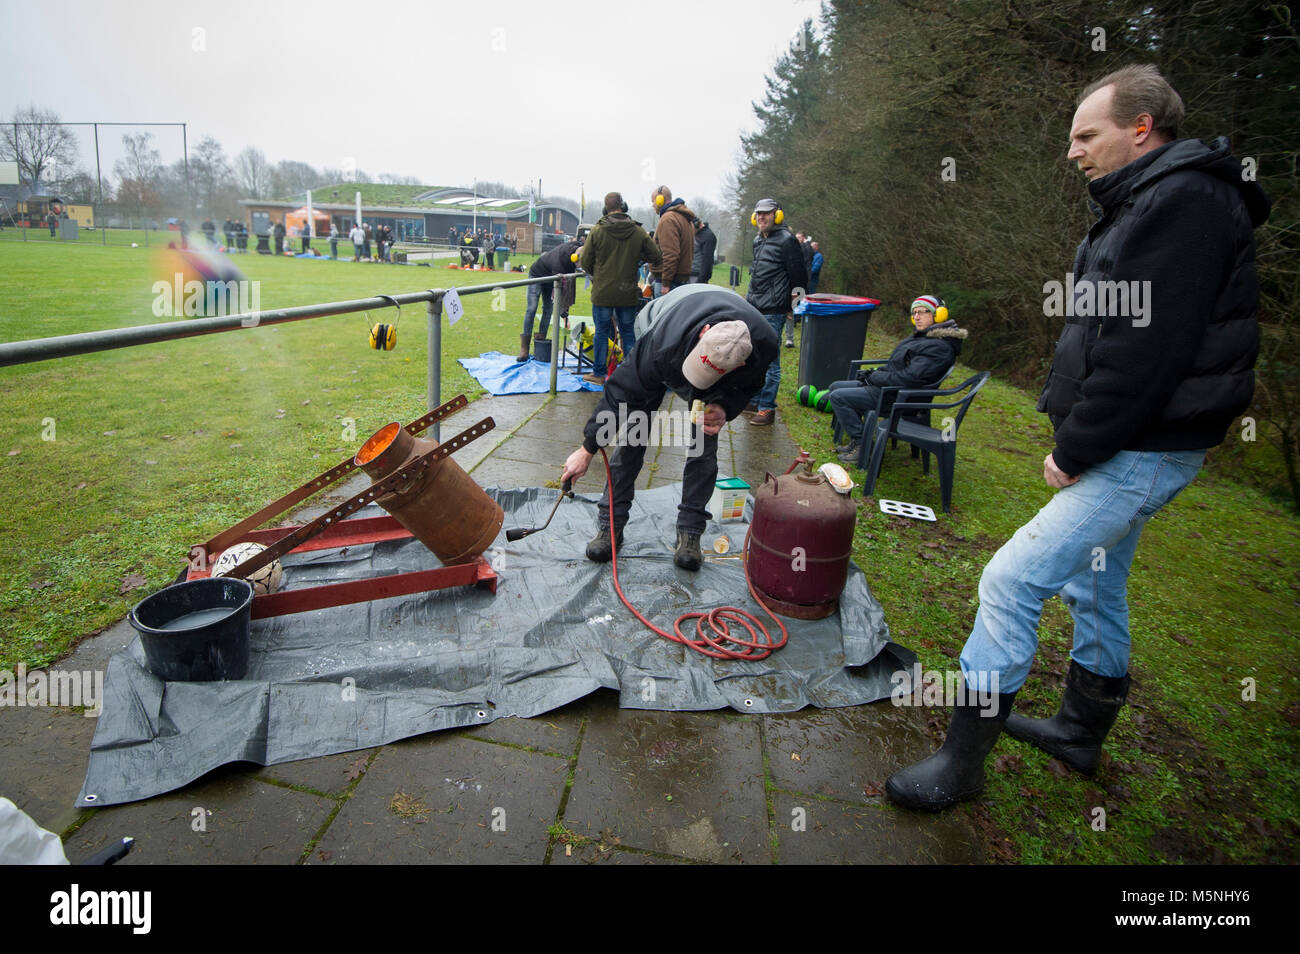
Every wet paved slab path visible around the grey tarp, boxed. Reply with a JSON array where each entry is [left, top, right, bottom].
[[0, 393, 984, 864]]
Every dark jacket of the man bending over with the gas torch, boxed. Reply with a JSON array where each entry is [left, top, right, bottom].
[[582, 285, 780, 454]]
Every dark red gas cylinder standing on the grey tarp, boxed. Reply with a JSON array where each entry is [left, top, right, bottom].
[[749, 461, 858, 620]]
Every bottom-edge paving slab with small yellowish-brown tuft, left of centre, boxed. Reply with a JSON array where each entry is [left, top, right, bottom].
[[308, 733, 568, 864]]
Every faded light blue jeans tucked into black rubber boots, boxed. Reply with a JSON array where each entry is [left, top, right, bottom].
[[961, 451, 1205, 693]]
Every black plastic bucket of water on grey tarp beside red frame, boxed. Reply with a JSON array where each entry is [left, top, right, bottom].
[[129, 576, 252, 682]]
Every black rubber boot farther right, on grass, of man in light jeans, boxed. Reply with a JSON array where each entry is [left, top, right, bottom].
[[1006, 659, 1128, 775]]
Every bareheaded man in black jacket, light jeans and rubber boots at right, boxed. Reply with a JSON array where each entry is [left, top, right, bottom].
[[885, 66, 1269, 811]]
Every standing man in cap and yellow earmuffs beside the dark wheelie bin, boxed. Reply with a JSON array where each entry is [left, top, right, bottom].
[[746, 199, 809, 428]]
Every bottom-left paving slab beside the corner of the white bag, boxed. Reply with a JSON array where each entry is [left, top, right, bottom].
[[65, 766, 335, 864]]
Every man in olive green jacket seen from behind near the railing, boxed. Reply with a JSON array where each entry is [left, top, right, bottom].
[[579, 192, 663, 387]]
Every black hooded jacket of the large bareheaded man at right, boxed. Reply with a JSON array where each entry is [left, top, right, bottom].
[[1039, 139, 1270, 477]]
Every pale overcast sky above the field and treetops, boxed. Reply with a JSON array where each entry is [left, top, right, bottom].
[[0, 0, 818, 205]]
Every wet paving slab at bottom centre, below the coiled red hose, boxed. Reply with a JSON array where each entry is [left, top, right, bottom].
[[564, 706, 768, 863]]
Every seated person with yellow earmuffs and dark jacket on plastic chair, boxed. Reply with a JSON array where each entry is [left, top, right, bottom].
[[827, 295, 969, 464]]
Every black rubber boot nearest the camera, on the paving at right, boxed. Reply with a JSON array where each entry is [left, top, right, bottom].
[[885, 682, 1015, 811]]
